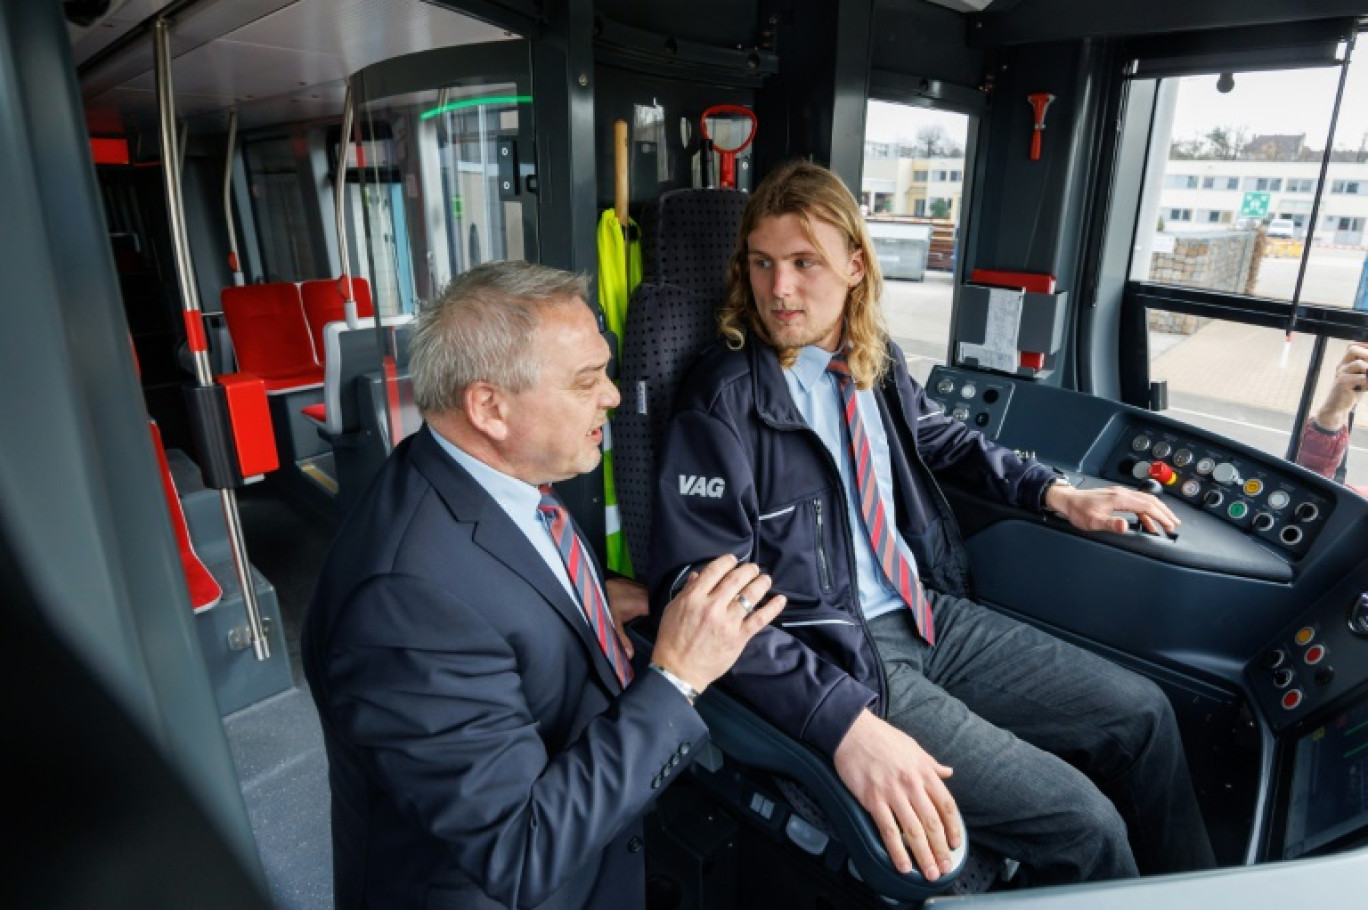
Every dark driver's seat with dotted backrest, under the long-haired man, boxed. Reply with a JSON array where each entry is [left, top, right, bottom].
[[613, 189, 999, 902]]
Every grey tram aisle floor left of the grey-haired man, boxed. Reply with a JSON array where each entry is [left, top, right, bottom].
[[223, 483, 335, 910]]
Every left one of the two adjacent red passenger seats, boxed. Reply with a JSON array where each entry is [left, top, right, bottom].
[[220, 282, 323, 385]]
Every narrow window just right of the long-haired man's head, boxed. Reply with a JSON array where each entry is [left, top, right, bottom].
[[860, 101, 970, 382]]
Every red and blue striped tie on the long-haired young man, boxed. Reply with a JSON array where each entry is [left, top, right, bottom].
[[826, 353, 936, 645]]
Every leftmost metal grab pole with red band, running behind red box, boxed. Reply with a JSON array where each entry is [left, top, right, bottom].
[[153, 19, 271, 661]]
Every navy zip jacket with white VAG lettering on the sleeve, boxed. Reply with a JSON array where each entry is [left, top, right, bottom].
[[650, 338, 1055, 757]]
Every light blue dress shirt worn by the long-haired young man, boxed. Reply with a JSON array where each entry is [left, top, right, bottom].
[[784, 345, 917, 620]]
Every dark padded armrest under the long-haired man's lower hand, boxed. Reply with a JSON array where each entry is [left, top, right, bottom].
[[628, 621, 969, 900]]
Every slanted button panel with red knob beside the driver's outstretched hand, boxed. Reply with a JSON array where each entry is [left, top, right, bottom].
[[1101, 420, 1334, 556]]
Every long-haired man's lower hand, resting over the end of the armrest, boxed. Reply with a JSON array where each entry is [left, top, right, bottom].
[[836, 710, 964, 881]]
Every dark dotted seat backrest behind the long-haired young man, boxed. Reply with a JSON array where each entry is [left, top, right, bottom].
[[613, 189, 747, 577]]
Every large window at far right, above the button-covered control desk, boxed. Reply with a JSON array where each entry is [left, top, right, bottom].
[[1127, 60, 1368, 484]]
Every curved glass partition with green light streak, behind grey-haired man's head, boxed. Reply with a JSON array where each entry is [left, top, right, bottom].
[[347, 40, 538, 446]]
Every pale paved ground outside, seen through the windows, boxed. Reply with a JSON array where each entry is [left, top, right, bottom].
[[884, 248, 1368, 484]]
